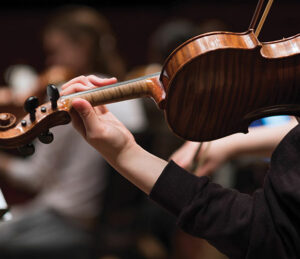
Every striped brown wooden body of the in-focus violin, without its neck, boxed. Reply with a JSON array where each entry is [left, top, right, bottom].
[[160, 30, 300, 141]]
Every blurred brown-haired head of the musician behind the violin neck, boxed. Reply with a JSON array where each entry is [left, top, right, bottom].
[[43, 6, 125, 79]]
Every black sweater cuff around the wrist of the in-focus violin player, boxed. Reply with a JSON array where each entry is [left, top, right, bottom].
[[149, 161, 209, 216]]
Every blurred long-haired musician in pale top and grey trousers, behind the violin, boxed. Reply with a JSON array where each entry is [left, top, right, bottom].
[[0, 6, 144, 258]]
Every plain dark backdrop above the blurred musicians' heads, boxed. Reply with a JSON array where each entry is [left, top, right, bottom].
[[0, 0, 299, 84]]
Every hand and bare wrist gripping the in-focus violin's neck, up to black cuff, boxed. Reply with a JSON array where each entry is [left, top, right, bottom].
[[62, 76, 167, 194]]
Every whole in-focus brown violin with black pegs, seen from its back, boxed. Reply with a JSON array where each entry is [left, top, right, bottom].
[[0, 0, 300, 155]]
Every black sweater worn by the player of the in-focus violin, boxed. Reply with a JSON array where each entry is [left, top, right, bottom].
[[150, 126, 300, 259]]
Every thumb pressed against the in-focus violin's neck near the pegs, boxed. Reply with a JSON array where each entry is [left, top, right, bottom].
[[72, 98, 98, 134]]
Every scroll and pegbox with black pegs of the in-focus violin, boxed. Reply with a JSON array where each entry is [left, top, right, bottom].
[[0, 85, 71, 155]]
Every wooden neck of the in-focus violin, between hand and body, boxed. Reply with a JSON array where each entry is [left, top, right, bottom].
[[62, 73, 165, 108]]
